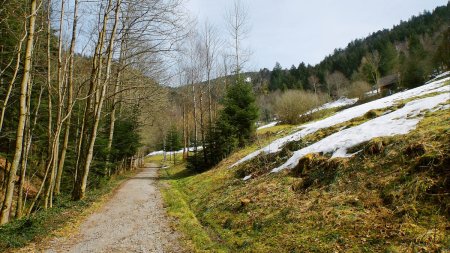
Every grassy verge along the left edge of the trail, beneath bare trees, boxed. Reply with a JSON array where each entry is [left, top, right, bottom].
[[0, 172, 134, 252]]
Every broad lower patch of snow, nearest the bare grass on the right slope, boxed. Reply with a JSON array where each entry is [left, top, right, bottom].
[[272, 93, 450, 172]]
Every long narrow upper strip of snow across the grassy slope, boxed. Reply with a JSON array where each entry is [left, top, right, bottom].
[[231, 77, 450, 167]]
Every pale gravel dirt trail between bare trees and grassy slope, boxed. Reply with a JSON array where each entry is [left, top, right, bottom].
[[45, 164, 183, 252]]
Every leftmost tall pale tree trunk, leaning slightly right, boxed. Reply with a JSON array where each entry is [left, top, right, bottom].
[[0, 0, 37, 224]]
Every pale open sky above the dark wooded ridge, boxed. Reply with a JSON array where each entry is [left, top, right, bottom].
[[186, 0, 447, 70]]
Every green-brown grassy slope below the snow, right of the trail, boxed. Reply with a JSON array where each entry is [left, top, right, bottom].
[[162, 90, 450, 252]]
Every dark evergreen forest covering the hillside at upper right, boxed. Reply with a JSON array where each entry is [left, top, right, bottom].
[[254, 4, 450, 97]]
